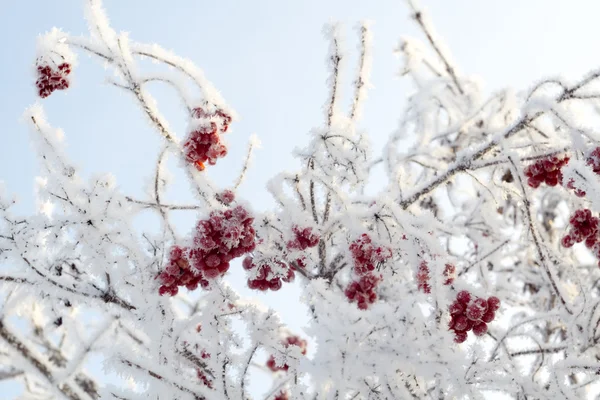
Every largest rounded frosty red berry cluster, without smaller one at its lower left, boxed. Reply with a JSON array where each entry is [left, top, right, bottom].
[[189, 206, 256, 279]]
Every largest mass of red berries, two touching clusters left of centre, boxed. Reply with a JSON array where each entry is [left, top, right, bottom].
[[158, 206, 256, 296]]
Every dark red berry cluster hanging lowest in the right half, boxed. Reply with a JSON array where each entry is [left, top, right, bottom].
[[448, 290, 500, 343]]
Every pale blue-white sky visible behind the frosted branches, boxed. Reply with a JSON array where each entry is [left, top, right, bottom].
[[0, 0, 600, 399]]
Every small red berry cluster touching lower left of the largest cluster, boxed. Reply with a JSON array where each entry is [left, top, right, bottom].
[[158, 246, 208, 296]]
